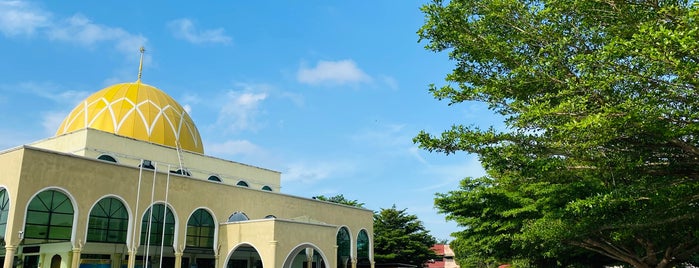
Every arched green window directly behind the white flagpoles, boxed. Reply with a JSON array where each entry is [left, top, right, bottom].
[[141, 204, 175, 246]]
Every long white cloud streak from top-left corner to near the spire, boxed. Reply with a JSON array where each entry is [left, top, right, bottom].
[[0, 1, 147, 57]]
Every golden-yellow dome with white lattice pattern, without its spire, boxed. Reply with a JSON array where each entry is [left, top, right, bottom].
[[56, 79, 204, 154]]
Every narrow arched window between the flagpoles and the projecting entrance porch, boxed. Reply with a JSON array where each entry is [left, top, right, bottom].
[[187, 208, 216, 248]]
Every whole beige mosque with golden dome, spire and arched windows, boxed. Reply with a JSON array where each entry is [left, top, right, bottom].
[[0, 50, 374, 268]]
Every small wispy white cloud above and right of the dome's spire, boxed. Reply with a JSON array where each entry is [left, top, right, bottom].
[[168, 19, 232, 44]]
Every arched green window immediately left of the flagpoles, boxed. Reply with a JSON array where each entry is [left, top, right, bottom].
[[87, 197, 129, 244]]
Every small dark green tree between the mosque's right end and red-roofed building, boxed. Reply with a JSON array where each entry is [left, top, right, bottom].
[[374, 205, 437, 267]]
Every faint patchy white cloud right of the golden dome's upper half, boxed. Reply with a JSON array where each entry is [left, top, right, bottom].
[[216, 91, 268, 131]]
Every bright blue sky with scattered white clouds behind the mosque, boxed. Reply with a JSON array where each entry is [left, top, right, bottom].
[[0, 0, 500, 240]]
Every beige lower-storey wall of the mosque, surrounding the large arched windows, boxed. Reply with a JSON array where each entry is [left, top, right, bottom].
[[0, 147, 373, 267]]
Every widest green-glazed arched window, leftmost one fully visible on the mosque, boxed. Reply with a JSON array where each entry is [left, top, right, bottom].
[[24, 190, 73, 243]]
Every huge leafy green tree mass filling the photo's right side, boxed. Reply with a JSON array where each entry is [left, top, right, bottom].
[[415, 0, 699, 267]]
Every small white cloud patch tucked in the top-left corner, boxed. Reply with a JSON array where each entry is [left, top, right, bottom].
[[0, 1, 51, 36]]
